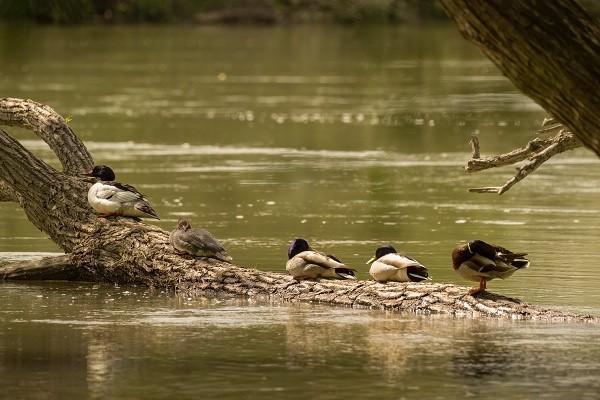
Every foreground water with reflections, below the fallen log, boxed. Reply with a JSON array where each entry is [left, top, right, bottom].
[[0, 283, 600, 399]]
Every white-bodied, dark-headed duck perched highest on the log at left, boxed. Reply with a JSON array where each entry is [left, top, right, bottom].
[[84, 165, 160, 219]]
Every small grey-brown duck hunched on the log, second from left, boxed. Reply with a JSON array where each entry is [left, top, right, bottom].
[[169, 218, 233, 262]]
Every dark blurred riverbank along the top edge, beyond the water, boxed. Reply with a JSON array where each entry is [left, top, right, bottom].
[[0, 0, 445, 24]]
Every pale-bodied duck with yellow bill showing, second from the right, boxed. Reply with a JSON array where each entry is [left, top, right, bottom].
[[367, 244, 429, 282]]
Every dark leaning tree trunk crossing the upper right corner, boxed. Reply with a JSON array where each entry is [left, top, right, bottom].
[[440, 0, 600, 156]]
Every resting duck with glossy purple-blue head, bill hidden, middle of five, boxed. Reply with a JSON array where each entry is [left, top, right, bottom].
[[285, 239, 356, 280]]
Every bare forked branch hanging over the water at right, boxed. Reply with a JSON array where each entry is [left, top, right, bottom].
[[465, 118, 581, 195]]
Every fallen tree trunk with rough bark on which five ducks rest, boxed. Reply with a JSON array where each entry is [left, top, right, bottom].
[[0, 99, 597, 321]]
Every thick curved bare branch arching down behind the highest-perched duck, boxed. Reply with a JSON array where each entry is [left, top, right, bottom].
[[0, 97, 94, 175]]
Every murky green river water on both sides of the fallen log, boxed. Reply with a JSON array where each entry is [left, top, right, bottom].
[[0, 25, 600, 398]]
